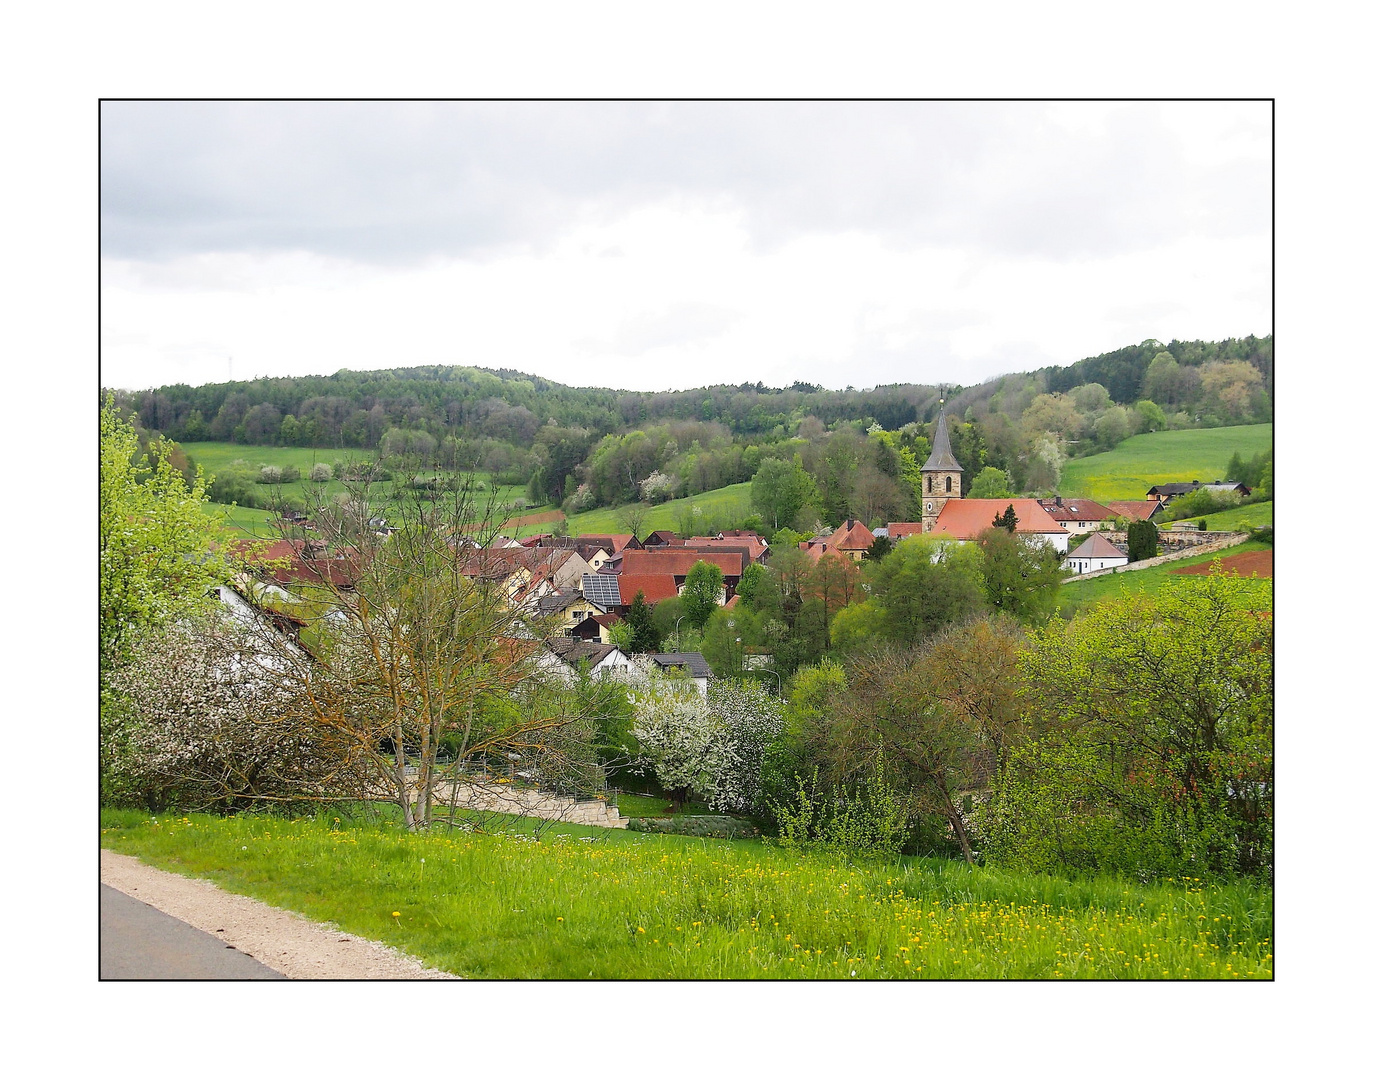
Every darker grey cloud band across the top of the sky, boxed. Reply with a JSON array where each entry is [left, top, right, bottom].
[[102, 102, 1270, 262]]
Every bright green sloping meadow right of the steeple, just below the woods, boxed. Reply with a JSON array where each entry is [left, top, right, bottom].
[[1059, 424, 1273, 502]]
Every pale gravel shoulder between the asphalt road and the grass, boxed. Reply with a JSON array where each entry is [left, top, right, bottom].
[[100, 848, 457, 980]]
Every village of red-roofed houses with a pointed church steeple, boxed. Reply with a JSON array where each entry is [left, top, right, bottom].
[[221, 400, 1249, 708]]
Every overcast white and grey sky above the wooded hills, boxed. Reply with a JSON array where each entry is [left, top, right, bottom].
[[100, 102, 1273, 390]]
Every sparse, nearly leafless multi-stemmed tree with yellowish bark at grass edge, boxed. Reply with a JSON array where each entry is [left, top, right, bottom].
[[247, 463, 606, 829]]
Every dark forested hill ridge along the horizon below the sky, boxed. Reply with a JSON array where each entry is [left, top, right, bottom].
[[119, 335, 1273, 449]]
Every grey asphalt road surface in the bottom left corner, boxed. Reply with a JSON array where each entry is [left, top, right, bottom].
[[100, 884, 286, 978]]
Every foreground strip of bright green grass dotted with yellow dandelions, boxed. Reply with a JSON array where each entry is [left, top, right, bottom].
[[100, 811, 1273, 978]]
